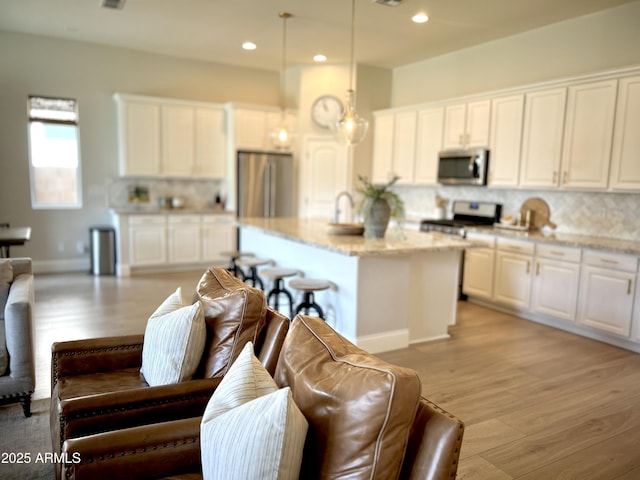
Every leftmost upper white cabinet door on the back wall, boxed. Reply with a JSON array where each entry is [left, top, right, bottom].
[[120, 101, 160, 176]]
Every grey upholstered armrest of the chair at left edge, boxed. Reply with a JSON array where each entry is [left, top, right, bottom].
[[4, 274, 35, 382]]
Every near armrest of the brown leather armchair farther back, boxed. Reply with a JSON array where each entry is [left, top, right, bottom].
[[51, 378, 222, 450]]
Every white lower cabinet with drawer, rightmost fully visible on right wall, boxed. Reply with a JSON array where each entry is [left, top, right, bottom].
[[578, 250, 638, 337]]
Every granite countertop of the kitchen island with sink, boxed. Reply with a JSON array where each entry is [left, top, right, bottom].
[[237, 218, 477, 256]]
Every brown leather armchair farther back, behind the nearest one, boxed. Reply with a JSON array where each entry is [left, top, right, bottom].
[[50, 269, 290, 458]]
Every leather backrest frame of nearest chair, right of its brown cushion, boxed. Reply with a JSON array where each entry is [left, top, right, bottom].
[[401, 398, 464, 480]]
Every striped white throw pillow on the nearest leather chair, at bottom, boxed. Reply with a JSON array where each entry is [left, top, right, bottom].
[[200, 343, 308, 480]]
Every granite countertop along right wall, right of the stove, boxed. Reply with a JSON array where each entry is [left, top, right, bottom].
[[469, 228, 640, 255]]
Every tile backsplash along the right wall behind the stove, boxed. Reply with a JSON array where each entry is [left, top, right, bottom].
[[395, 186, 640, 241]]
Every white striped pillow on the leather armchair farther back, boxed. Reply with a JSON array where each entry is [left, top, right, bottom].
[[141, 287, 207, 386]]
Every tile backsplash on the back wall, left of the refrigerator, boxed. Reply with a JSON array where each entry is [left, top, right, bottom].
[[107, 178, 226, 210]]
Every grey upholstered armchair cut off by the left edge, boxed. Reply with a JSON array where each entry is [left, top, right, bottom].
[[0, 258, 36, 417]]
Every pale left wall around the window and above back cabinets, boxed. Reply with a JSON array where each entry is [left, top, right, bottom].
[[0, 32, 280, 270]]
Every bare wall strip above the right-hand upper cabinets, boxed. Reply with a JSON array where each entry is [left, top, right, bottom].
[[391, 1, 640, 107]]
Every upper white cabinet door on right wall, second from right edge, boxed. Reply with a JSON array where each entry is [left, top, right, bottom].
[[562, 80, 618, 189]]
